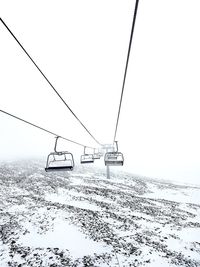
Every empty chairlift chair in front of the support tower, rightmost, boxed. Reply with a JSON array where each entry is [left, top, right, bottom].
[[104, 141, 124, 166]]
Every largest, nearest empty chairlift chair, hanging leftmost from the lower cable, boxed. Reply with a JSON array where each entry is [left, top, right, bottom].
[[45, 136, 74, 172]]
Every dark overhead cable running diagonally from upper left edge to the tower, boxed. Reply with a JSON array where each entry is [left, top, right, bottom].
[[0, 18, 101, 148]]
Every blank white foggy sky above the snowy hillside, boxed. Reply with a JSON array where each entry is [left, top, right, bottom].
[[0, 0, 200, 183]]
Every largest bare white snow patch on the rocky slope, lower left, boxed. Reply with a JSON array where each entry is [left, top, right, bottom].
[[18, 219, 111, 258]]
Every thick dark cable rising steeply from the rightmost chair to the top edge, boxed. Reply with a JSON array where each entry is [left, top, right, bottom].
[[113, 0, 139, 144]]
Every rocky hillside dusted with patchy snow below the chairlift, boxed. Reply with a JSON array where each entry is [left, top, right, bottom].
[[0, 161, 200, 267]]
